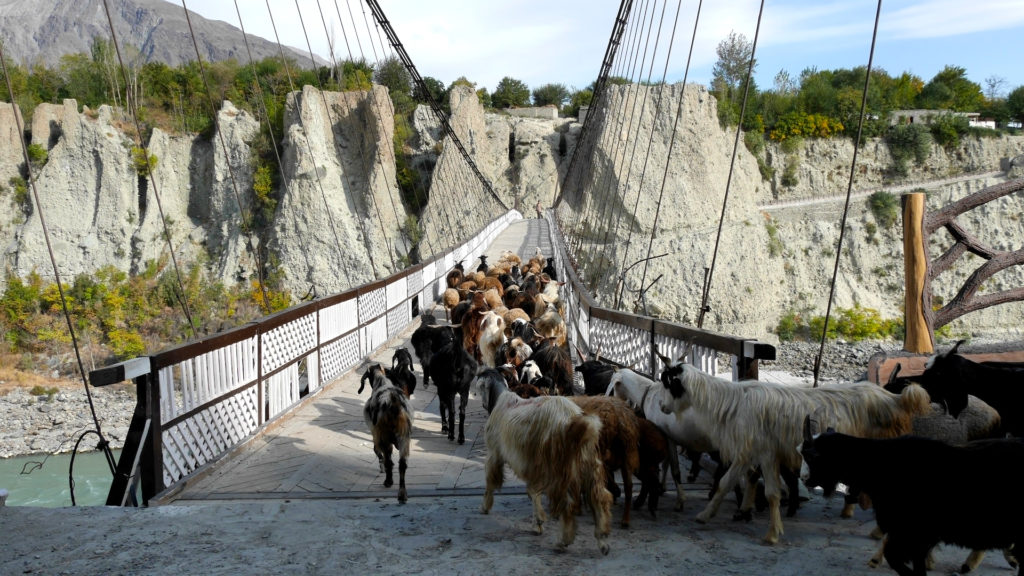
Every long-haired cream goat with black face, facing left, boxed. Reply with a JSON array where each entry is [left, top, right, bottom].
[[660, 357, 931, 544]]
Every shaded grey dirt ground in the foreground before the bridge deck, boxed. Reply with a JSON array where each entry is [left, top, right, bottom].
[[0, 477, 1009, 576]]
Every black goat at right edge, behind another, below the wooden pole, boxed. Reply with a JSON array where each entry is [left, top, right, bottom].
[[909, 340, 1024, 437]]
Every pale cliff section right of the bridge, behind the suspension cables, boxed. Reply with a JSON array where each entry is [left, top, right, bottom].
[[566, 81, 1024, 340]]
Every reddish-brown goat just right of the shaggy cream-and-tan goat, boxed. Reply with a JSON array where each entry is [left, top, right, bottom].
[[572, 396, 638, 528]]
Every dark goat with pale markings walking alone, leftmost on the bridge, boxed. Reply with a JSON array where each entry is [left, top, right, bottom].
[[356, 364, 413, 502]]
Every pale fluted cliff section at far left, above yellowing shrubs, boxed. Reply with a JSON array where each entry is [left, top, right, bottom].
[[0, 100, 259, 291]]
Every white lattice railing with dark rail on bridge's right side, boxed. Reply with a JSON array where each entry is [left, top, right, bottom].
[[545, 211, 775, 380]]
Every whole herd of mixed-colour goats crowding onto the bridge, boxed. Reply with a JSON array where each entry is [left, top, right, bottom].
[[359, 250, 1024, 575]]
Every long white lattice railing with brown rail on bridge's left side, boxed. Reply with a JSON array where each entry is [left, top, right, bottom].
[[90, 210, 522, 502]]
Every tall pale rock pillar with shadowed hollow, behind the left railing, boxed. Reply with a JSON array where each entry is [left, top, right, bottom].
[[269, 86, 410, 296]]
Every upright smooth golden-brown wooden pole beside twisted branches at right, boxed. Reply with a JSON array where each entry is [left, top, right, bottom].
[[902, 193, 935, 354]]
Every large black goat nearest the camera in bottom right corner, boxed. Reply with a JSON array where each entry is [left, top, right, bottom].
[[801, 418, 1024, 576]]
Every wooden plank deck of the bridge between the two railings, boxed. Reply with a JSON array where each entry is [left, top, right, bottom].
[[163, 219, 551, 503]]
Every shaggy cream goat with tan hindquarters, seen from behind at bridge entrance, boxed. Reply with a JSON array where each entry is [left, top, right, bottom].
[[477, 385, 611, 554]]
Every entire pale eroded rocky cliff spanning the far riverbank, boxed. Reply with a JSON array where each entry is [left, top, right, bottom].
[[0, 79, 1024, 339]]
